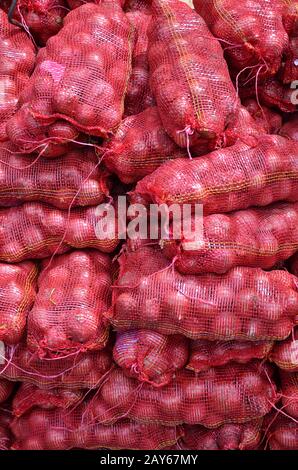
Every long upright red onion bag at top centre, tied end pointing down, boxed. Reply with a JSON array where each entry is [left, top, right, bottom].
[[148, 0, 239, 148]]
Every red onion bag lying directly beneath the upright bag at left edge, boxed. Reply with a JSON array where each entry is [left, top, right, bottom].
[[0, 344, 112, 390]]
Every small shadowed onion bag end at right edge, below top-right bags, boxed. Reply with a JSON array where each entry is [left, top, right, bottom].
[[239, 77, 297, 113]]
